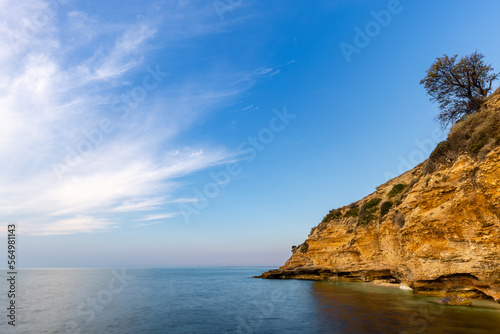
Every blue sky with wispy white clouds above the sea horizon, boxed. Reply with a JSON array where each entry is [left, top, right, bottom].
[[0, 0, 500, 267]]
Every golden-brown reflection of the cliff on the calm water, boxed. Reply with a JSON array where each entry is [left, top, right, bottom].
[[311, 282, 500, 334]]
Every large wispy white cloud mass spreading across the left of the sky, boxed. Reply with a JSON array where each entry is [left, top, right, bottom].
[[0, 1, 282, 235]]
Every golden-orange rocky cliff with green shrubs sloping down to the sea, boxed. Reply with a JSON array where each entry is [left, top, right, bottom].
[[260, 90, 500, 302]]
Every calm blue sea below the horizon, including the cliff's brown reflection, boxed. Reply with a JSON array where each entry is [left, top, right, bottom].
[[0, 268, 500, 334]]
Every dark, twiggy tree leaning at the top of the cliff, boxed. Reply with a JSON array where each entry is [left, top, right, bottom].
[[420, 51, 500, 127]]
